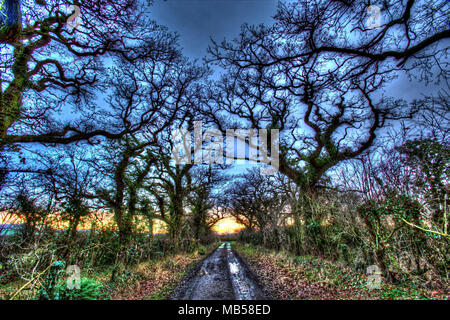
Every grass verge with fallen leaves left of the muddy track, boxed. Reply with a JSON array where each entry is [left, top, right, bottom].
[[0, 243, 218, 300]]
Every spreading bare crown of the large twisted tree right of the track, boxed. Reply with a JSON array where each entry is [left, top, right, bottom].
[[208, 0, 450, 194]]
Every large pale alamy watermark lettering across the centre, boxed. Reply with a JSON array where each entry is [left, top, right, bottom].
[[172, 121, 280, 175]]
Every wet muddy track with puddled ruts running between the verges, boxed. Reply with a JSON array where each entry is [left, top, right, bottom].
[[170, 243, 268, 300]]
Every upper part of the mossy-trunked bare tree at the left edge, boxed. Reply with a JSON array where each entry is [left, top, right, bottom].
[[0, 0, 179, 148]]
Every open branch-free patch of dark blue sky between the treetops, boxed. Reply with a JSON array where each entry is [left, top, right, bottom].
[[150, 0, 278, 59]]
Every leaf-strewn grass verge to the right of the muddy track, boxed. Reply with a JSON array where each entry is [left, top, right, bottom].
[[232, 242, 449, 300]]
